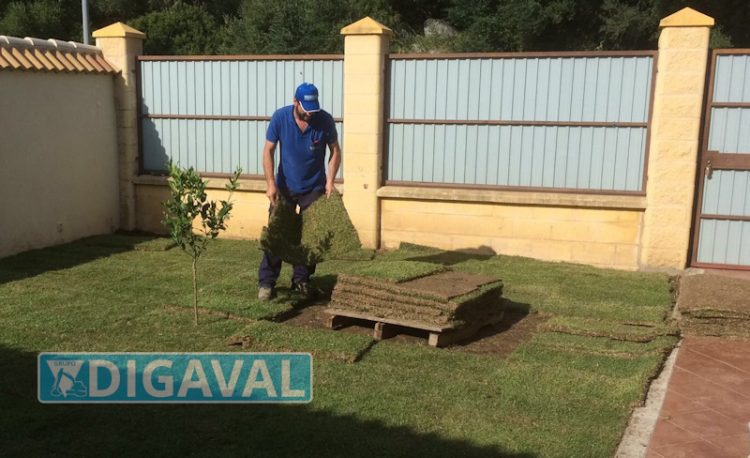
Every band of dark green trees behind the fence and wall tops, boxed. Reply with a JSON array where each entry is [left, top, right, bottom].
[[0, 0, 750, 54]]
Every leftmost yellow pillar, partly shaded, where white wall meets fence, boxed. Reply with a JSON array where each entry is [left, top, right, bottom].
[[93, 22, 146, 230]]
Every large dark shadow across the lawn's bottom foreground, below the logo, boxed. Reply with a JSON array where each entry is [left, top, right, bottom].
[[0, 347, 534, 458]]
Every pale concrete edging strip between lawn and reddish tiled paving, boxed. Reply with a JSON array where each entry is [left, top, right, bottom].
[[615, 341, 682, 458]]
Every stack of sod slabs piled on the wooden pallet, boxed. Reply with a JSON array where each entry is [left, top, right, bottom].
[[330, 261, 503, 329]]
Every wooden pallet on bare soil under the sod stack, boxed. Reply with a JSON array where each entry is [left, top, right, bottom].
[[325, 308, 504, 347]]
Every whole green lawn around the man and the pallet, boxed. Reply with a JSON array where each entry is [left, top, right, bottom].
[[0, 235, 677, 457]]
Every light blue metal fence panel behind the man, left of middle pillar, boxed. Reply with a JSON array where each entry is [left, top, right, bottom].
[[139, 57, 344, 178]]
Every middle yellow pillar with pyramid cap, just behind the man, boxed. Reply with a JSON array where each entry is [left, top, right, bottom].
[[341, 17, 393, 248]]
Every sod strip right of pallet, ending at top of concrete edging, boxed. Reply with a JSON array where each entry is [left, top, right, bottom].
[[531, 332, 679, 358]]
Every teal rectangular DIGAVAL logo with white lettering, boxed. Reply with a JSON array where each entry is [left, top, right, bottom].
[[37, 352, 313, 403]]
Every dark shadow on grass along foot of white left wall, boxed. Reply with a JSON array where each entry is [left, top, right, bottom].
[[0, 232, 170, 284]]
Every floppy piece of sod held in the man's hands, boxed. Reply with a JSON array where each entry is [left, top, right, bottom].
[[260, 191, 374, 265]]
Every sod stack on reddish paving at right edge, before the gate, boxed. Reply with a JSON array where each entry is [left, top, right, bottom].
[[677, 275, 750, 337]]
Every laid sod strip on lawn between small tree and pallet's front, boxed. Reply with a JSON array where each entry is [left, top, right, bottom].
[[227, 321, 374, 363]]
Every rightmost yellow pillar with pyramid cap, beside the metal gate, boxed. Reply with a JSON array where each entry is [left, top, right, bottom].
[[640, 8, 714, 270]]
